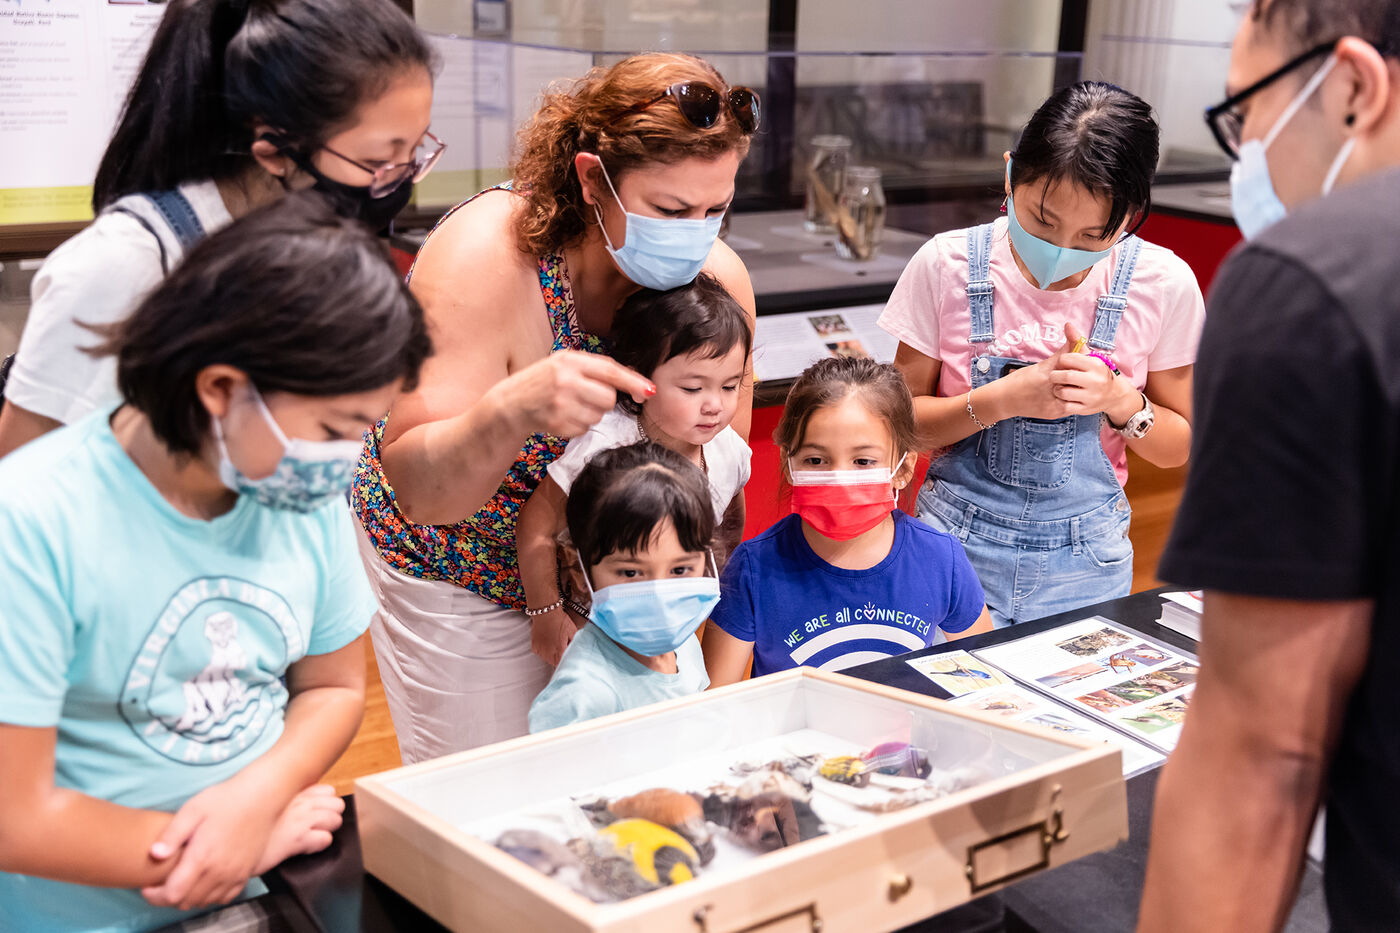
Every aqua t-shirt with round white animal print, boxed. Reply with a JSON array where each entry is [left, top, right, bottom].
[[0, 410, 375, 933]]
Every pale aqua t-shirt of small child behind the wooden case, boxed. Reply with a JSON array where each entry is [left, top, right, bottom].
[[529, 625, 710, 733]]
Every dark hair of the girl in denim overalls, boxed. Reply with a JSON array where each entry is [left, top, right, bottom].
[[1011, 81, 1161, 235]]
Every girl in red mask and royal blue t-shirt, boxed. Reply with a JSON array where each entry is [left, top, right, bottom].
[[704, 359, 991, 686]]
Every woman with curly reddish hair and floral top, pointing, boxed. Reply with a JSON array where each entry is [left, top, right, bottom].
[[354, 53, 759, 761]]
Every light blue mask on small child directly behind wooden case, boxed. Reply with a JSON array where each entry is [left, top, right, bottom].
[[584, 556, 720, 657]]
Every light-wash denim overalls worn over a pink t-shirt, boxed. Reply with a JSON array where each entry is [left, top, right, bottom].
[[918, 224, 1142, 628]]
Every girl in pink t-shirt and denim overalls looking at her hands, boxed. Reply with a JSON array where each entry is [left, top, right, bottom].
[[881, 81, 1204, 626]]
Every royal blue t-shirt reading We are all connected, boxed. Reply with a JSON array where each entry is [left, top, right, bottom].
[[710, 511, 984, 677]]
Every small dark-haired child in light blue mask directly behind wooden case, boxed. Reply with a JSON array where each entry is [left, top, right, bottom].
[[529, 441, 720, 733]]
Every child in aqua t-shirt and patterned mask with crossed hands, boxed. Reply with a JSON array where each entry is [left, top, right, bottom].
[[0, 193, 430, 933]]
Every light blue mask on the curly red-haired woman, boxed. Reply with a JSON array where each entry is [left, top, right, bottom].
[[594, 160, 724, 291]]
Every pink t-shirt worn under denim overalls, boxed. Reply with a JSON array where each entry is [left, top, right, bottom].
[[879, 217, 1205, 483]]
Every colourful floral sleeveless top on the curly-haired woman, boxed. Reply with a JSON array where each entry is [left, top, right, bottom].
[[351, 189, 608, 609]]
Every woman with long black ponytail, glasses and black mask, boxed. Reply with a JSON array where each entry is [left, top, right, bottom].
[[0, 0, 441, 457]]
